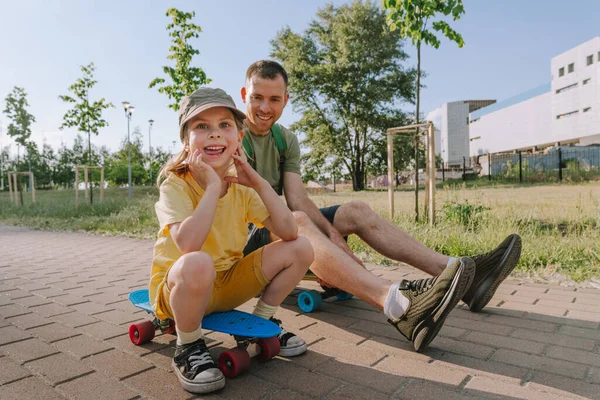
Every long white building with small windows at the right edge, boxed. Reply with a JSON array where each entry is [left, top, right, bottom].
[[469, 36, 600, 157]]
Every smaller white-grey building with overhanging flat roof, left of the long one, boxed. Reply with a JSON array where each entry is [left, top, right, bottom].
[[426, 100, 495, 167]]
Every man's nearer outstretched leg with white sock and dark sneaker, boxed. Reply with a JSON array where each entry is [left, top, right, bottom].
[[294, 212, 475, 352]]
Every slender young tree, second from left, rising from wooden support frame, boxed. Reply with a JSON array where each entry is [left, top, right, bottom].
[[58, 63, 114, 203]]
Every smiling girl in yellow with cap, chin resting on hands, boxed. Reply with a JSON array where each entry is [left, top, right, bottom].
[[150, 88, 313, 393]]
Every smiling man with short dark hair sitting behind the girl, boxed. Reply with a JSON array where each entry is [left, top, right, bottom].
[[241, 60, 521, 352]]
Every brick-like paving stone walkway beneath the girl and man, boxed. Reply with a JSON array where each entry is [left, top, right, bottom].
[[0, 226, 600, 400]]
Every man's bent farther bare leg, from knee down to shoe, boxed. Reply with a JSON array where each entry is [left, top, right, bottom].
[[333, 200, 450, 276]]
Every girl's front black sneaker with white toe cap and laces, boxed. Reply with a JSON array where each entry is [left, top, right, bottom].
[[171, 339, 225, 393]]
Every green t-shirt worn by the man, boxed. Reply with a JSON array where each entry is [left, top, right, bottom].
[[244, 124, 300, 192]]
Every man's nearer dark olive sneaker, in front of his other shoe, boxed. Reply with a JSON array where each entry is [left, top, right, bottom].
[[388, 257, 475, 353]]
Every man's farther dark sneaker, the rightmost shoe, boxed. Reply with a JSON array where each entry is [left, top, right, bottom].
[[463, 234, 521, 312]]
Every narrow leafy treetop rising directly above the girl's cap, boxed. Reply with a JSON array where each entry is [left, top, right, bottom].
[[149, 8, 211, 111]]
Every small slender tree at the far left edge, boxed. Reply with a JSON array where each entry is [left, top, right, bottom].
[[4, 86, 35, 165]]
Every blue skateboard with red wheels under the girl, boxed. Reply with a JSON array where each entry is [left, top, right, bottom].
[[129, 289, 281, 378]]
